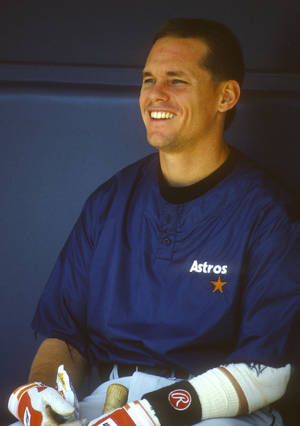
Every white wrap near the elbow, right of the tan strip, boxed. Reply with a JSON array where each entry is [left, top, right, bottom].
[[225, 364, 291, 413]]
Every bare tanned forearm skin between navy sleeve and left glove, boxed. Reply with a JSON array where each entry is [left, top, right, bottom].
[[28, 338, 89, 390]]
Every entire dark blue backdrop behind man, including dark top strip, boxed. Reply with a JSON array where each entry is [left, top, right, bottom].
[[0, 0, 300, 425]]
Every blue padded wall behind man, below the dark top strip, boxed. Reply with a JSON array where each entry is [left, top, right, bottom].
[[0, 79, 300, 422]]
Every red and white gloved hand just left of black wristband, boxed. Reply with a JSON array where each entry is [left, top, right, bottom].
[[88, 399, 160, 426]]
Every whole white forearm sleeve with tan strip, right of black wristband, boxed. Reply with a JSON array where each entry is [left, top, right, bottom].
[[190, 363, 291, 420]]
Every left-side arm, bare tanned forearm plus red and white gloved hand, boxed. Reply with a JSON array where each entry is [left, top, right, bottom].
[[8, 338, 88, 426]]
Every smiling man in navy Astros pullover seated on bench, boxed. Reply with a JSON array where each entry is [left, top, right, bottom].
[[10, 19, 300, 426]]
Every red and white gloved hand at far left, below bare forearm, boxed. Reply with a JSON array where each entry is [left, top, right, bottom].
[[8, 382, 82, 426]]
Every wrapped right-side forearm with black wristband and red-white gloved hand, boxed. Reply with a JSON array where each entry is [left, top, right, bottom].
[[89, 363, 291, 426]]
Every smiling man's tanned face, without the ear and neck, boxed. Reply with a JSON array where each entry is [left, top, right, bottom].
[[140, 37, 220, 152]]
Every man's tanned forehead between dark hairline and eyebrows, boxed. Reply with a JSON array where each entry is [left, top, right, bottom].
[[145, 37, 208, 71]]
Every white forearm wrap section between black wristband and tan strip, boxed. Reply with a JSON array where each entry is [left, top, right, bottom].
[[190, 368, 240, 420]]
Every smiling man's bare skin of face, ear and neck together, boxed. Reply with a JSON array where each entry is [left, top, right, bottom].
[[140, 37, 240, 186]]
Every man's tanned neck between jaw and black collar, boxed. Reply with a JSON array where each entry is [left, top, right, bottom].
[[159, 140, 230, 186]]
